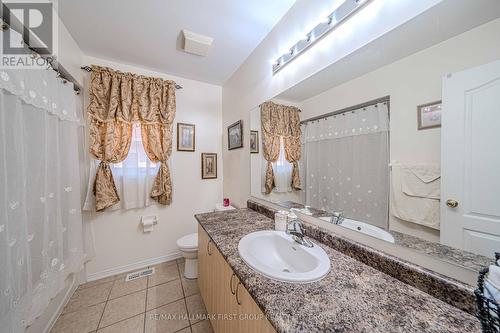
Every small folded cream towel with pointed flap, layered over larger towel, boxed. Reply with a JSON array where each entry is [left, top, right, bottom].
[[401, 164, 441, 200]]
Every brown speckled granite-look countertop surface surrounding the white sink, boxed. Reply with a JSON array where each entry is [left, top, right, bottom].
[[195, 209, 481, 333]]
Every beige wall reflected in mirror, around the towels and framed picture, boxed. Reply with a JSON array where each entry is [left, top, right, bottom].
[[300, 19, 500, 241]]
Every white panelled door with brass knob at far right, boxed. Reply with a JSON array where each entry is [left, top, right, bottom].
[[441, 61, 500, 257]]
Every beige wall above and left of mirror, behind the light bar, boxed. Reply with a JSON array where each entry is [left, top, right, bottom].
[[222, 0, 441, 206]]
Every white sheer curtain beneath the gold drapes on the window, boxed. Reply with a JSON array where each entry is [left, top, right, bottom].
[[83, 124, 159, 211]]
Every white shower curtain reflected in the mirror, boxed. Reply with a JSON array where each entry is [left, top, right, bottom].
[[303, 103, 389, 228]]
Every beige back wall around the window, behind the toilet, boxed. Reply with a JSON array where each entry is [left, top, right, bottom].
[[84, 57, 222, 279]]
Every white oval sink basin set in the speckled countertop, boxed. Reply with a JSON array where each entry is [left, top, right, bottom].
[[238, 230, 330, 283]]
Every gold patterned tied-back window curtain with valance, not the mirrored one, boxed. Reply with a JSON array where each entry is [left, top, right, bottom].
[[87, 66, 175, 211]]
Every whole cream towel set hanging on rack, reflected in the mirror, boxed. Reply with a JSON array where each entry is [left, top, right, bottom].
[[391, 164, 440, 230]]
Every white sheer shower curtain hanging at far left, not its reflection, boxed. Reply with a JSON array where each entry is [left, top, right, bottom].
[[0, 70, 83, 332]]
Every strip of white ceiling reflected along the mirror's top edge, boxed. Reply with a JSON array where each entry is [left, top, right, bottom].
[[275, 0, 500, 103]]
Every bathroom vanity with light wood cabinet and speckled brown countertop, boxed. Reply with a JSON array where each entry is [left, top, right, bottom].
[[196, 209, 480, 333]]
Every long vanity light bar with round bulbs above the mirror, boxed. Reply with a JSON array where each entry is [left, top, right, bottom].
[[273, 0, 371, 74]]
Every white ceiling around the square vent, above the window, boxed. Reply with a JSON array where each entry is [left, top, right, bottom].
[[59, 0, 295, 84]]
